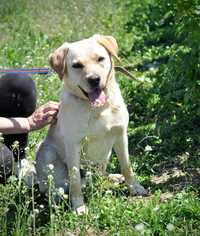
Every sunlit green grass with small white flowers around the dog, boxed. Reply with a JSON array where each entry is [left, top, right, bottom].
[[0, 0, 200, 236]]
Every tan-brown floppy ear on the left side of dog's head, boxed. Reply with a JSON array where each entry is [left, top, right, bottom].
[[49, 43, 69, 80]]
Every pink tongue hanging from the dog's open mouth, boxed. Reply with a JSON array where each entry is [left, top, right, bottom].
[[88, 89, 106, 107]]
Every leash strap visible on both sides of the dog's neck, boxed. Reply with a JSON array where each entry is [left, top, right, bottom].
[[0, 66, 144, 83]]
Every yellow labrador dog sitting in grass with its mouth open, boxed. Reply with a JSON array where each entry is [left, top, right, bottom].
[[36, 35, 146, 214]]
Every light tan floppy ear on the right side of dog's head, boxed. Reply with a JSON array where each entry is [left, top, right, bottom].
[[94, 34, 120, 61]]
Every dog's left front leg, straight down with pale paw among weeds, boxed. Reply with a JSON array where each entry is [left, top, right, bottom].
[[65, 142, 87, 215]]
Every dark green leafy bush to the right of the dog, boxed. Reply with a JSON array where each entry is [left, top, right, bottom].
[[113, 0, 200, 159]]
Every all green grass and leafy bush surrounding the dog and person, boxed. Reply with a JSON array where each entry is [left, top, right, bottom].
[[0, 0, 200, 236]]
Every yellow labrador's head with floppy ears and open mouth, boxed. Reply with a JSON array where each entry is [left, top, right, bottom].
[[49, 35, 118, 106]]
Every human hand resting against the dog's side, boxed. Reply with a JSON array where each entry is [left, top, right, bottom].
[[28, 101, 60, 131]]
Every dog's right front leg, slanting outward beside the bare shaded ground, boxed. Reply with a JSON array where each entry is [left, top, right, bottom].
[[114, 130, 147, 195]]
